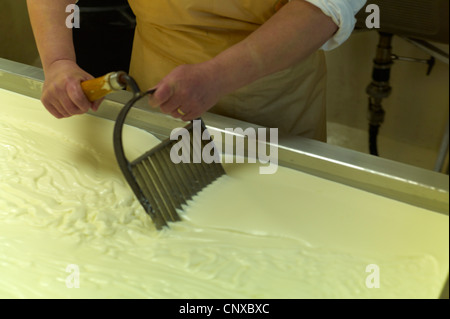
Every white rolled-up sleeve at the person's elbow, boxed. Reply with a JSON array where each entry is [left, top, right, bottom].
[[298, 0, 366, 51]]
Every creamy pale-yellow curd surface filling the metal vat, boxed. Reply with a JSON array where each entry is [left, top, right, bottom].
[[0, 90, 449, 298]]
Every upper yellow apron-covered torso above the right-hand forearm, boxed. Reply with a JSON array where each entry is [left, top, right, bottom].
[[129, 0, 285, 83]]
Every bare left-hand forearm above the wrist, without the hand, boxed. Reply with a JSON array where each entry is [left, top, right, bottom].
[[27, 0, 76, 71]]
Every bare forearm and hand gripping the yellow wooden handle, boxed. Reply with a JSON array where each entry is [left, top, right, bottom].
[[27, 0, 100, 118]]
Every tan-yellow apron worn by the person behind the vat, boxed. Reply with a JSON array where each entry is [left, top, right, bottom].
[[129, 0, 326, 141]]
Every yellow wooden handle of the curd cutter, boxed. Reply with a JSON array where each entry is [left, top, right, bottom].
[[81, 72, 125, 102]]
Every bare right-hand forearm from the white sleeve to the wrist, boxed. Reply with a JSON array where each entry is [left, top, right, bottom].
[[211, 0, 337, 94]]
